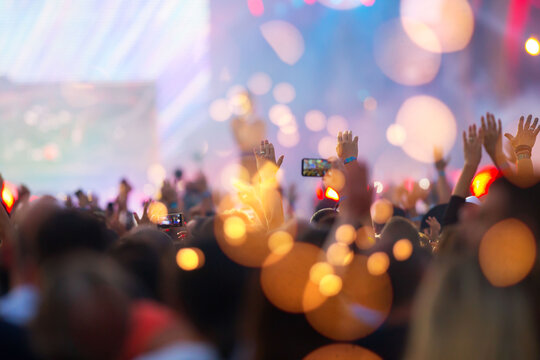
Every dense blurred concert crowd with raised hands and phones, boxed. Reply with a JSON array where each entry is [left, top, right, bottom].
[[0, 114, 540, 360]]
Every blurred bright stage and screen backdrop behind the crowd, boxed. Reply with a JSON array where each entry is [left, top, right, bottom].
[[0, 0, 540, 216]]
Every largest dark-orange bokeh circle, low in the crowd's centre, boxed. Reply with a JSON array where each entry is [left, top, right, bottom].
[[306, 255, 392, 341]]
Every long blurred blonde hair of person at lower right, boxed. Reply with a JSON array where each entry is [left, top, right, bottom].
[[405, 256, 538, 360]]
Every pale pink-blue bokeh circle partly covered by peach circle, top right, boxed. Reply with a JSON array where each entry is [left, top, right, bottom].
[[373, 20, 441, 86]]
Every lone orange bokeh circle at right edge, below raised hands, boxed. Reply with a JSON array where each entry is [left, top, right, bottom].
[[478, 219, 536, 287]]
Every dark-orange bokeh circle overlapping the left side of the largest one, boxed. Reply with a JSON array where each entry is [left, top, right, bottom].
[[261, 243, 325, 313]]
